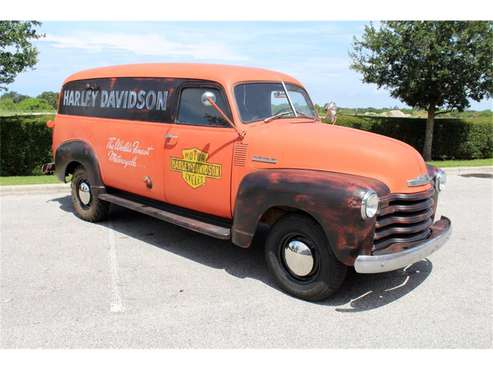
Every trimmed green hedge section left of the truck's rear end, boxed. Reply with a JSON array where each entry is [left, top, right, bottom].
[[0, 116, 53, 176]]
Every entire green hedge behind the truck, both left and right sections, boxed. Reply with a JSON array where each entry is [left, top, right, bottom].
[[0, 115, 493, 176]]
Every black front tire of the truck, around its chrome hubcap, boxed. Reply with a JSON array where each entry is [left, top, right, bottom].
[[265, 214, 347, 301]]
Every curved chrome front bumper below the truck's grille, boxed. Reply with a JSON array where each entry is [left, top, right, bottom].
[[354, 216, 452, 274]]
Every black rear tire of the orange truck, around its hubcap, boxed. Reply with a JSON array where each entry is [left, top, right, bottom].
[[71, 166, 110, 222]]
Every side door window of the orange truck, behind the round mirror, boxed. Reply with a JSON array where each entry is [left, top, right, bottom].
[[176, 87, 229, 126]]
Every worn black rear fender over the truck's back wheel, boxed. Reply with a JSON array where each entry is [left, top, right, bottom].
[[55, 140, 105, 192]]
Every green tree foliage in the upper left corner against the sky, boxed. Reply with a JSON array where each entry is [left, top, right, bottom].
[[0, 21, 44, 90]]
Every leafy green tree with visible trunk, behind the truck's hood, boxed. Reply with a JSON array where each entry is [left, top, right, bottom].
[[350, 21, 493, 160]]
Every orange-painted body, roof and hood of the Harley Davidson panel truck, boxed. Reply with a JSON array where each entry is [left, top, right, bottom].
[[51, 64, 431, 218]]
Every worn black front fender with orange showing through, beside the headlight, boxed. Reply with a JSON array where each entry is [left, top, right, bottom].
[[232, 169, 389, 266]]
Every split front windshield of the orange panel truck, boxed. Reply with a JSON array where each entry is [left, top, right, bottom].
[[235, 82, 316, 123]]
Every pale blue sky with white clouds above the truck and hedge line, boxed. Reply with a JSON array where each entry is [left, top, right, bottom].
[[8, 21, 492, 110]]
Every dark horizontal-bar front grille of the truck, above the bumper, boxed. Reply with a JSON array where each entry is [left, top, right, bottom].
[[373, 188, 435, 251]]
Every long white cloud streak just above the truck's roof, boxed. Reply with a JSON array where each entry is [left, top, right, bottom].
[[42, 32, 248, 61]]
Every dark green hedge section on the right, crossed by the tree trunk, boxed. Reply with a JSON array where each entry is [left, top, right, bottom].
[[326, 115, 493, 160]]
